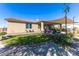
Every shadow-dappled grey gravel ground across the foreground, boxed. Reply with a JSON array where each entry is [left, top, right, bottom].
[[0, 39, 79, 56]]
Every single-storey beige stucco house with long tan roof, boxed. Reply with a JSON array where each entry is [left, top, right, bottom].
[[5, 18, 73, 35]]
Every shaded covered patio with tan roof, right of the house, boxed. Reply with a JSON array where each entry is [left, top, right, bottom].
[[38, 18, 74, 33]]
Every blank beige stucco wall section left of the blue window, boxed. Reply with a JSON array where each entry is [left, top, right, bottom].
[[7, 22, 26, 33]]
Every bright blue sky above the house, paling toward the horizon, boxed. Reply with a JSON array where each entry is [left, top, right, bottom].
[[0, 3, 79, 27]]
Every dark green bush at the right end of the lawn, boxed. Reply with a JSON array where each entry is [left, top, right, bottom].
[[54, 34, 72, 46]]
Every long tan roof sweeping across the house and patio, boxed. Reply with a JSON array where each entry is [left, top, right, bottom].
[[5, 18, 73, 25]]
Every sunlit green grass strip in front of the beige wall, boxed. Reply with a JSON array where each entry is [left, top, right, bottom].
[[3, 34, 50, 45]]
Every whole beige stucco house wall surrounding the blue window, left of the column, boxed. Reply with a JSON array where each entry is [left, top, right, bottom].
[[7, 22, 40, 34]]
